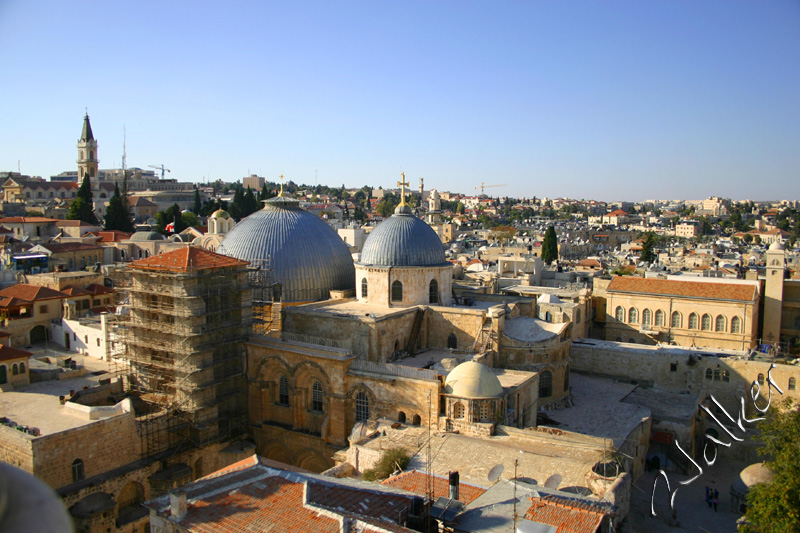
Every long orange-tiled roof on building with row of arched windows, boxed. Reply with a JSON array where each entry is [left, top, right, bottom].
[[607, 276, 758, 302]]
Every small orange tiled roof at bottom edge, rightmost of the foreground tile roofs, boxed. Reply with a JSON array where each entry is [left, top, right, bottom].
[[525, 496, 605, 533]]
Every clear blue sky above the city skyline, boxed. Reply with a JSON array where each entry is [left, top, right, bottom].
[[0, 0, 800, 201]]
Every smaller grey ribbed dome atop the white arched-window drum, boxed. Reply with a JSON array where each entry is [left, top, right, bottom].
[[359, 207, 447, 266]]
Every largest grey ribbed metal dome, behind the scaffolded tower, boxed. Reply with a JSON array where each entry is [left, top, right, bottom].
[[217, 197, 355, 302]]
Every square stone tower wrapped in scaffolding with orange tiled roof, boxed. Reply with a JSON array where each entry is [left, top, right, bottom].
[[113, 247, 252, 455]]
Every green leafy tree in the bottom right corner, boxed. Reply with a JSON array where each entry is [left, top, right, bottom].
[[741, 399, 800, 533]]
